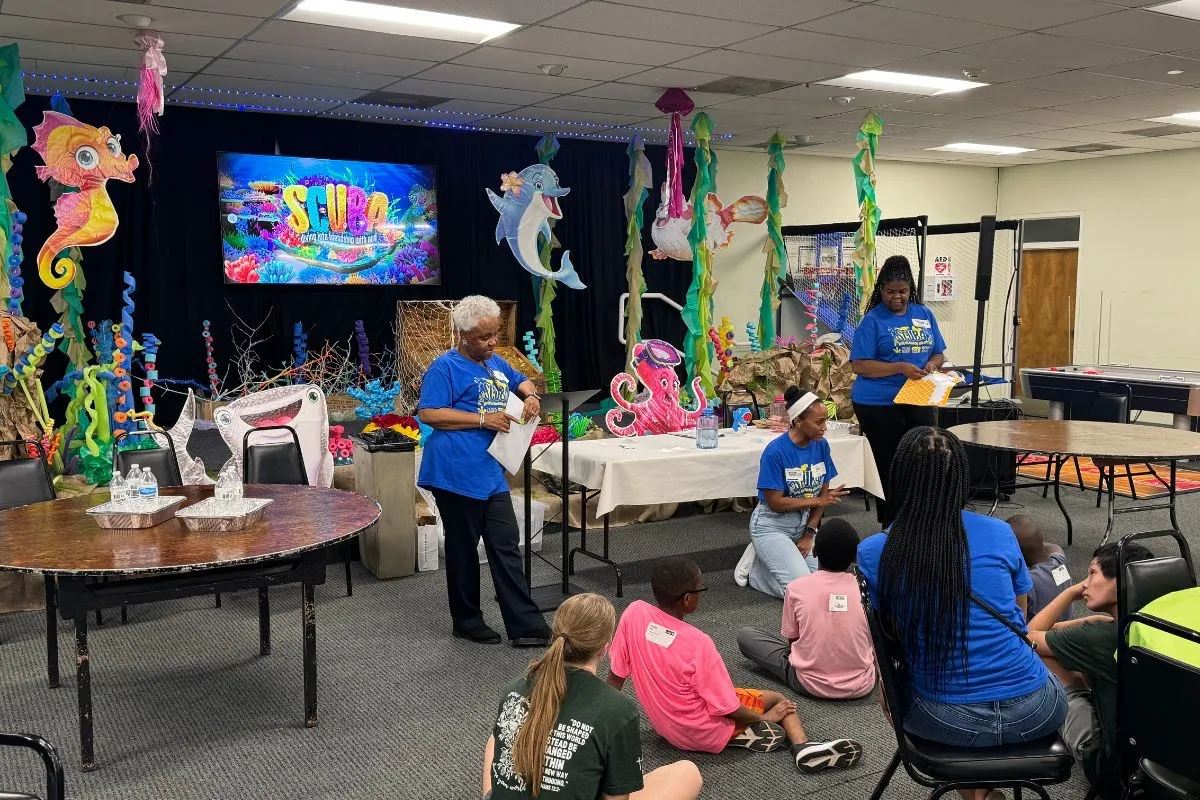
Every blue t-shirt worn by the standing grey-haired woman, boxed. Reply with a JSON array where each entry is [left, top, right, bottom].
[[416, 349, 527, 500]]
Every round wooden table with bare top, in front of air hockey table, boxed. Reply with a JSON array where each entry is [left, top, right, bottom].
[[950, 420, 1200, 545]]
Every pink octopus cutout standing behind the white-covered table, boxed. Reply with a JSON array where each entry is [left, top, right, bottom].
[[605, 339, 704, 437]]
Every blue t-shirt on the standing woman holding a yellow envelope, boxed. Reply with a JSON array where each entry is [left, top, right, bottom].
[[850, 302, 946, 405]]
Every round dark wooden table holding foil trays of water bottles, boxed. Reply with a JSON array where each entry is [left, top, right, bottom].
[[0, 485, 380, 772]]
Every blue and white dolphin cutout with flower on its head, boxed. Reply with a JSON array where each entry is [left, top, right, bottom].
[[484, 164, 587, 289]]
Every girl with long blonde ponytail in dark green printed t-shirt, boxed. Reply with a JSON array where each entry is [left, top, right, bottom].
[[484, 594, 701, 800]]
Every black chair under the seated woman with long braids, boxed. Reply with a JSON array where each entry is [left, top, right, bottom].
[[858, 573, 1074, 800]]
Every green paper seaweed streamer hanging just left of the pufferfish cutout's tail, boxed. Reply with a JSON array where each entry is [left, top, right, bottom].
[[683, 112, 716, 401]]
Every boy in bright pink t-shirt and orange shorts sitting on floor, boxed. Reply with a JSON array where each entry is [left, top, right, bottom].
[[608, 557, 863, 772]]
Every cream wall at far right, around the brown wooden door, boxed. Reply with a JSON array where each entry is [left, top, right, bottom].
[[1000, 150, 1200, 369]]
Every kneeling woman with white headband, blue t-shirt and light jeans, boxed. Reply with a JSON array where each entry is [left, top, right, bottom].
[[742, 386, 846, 597]]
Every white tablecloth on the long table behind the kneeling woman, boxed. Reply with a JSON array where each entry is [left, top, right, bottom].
[[533, 431, 883, 517]]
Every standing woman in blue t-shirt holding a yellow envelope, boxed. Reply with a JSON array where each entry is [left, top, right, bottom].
[[850, 255, 946, 527]]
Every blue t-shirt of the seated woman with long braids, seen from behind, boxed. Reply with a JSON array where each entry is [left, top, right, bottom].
[[858, 511, 1049, 704]]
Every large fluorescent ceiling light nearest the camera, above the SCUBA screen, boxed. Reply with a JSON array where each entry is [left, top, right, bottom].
[[282, 0, 521, 44]]
